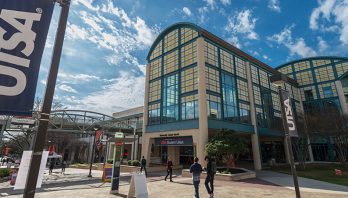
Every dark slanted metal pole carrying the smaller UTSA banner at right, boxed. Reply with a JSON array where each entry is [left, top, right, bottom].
[[278, 86, 301, 198]]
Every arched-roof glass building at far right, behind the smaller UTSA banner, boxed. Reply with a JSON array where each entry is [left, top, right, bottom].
[[276, 57, 348, 161]]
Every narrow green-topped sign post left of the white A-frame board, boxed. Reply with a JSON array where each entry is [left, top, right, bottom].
[[110, 132, 124, 194]]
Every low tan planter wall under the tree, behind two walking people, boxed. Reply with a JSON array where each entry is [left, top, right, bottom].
[[182, 168, 256, 181]]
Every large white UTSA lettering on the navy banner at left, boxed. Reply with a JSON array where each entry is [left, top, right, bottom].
[[0, 9, 41, 96]]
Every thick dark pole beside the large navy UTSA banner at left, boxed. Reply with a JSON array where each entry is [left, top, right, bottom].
[[23, 0, 70, 198]]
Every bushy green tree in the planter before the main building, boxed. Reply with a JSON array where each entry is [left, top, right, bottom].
[[205, 129, 248, 167]]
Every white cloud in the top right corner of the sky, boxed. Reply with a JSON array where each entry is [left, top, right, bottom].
[[309, 0, 348, 44]]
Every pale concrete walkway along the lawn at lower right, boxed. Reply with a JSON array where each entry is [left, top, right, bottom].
[[256, 171, 348, 197]]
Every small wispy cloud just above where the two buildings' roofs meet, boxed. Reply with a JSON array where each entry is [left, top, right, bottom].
[[267, 25, 317, 58]]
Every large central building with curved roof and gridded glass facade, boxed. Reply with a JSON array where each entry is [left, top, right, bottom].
[[142, 23, 303, 170]]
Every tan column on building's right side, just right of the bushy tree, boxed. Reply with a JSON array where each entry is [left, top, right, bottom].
[[246, 62, 262, 170]]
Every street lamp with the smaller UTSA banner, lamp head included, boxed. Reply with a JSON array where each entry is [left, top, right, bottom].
[[270, 74, 301, 198]]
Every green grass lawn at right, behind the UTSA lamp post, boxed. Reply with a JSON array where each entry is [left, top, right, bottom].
[[271, 164, 348, 186]]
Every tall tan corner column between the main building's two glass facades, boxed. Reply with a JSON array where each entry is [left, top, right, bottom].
[[196, 37, 208, 166]]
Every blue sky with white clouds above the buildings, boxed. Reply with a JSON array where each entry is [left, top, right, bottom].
[[36, 0, 348, 115]]
